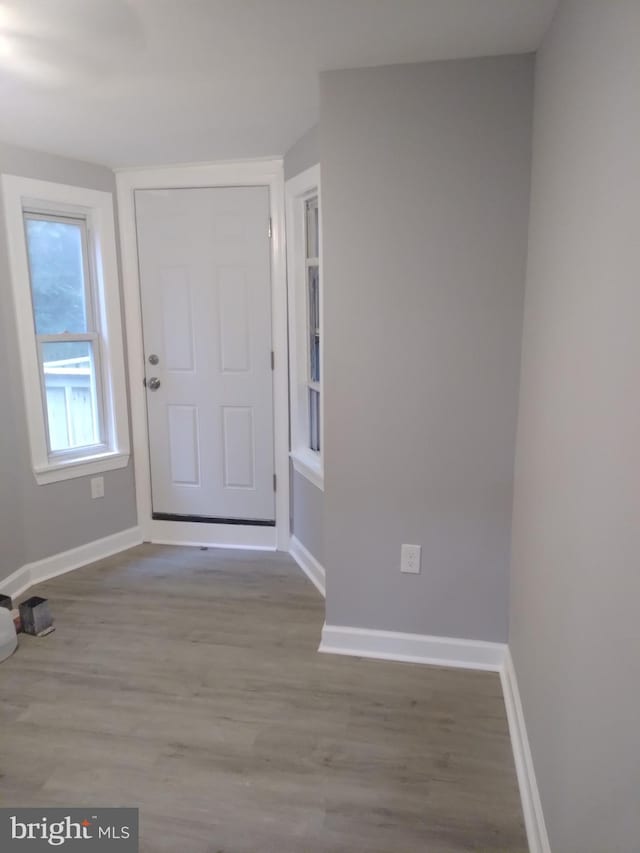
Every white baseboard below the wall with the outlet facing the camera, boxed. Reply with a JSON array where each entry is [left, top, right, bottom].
[[318, 624, 507, 672]]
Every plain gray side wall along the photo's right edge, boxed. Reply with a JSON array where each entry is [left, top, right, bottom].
[[509, 0, 640, 853]]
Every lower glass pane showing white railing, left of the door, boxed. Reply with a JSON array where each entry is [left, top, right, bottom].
[[41, 341, 100, 451]]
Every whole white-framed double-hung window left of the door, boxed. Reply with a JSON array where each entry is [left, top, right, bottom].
[[3, 175, 129, 483]]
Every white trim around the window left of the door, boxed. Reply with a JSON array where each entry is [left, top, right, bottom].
[[2, 175, 130, 485]]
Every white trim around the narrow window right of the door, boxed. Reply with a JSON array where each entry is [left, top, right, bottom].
[[285, 165, 324, 491]]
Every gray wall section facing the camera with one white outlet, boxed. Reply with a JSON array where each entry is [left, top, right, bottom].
[[320, 56, 533, 641]]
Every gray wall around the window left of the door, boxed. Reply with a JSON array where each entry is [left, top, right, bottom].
[[0, 144, 136, 579]]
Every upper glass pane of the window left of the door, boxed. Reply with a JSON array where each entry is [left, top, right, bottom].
[[25, 216, 87, 335]]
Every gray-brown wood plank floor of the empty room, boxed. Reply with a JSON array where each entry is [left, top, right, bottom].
[[0, 545, 526, 853]]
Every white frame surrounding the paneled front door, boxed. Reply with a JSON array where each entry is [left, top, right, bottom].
[[116, 159, 289, 551]]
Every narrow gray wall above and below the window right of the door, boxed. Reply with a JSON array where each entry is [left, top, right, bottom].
[[284, 125, 324, 565]]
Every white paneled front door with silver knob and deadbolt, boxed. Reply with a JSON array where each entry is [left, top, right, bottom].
[[135, 187, 275, 525]]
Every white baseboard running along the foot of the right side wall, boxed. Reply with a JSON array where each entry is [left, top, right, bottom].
[[500, 649, 551, 853]]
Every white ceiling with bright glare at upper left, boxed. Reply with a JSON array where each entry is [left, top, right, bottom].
[[0, 0, 557, 166]]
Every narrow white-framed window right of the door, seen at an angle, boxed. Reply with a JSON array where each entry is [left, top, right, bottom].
[[286, 166, 323, 488]]
